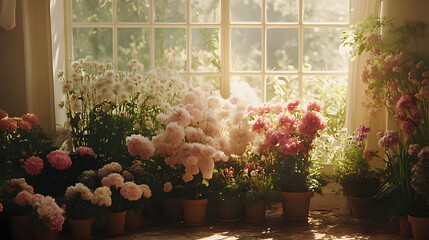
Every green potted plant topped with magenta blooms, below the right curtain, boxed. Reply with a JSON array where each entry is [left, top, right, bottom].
[[332, 125, 381, 218]]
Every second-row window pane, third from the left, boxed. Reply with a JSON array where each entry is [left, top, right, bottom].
[[155, 28, 186, 70]]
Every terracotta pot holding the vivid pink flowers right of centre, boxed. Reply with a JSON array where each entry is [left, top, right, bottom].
[[280, 192, 314, 221]]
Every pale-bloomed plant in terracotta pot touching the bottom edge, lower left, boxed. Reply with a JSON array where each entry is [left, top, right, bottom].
[[65, 183, 96, 239]]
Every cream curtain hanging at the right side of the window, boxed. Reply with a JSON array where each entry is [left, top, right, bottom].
[[346, 0, 381, 132]]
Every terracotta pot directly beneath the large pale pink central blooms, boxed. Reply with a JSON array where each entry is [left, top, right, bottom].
[[183, 199, 208, 226]]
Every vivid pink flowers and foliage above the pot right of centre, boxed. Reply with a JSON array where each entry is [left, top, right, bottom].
[[249, 99, 326, 192]]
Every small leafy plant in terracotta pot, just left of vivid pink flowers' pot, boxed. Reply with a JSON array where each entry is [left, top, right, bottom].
[[239, 163, 278, 222]]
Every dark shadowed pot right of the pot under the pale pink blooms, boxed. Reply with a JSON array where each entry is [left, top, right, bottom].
[[216, 200, 244, 222]]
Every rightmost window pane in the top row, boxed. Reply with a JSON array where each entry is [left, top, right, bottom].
[[304, 0, 349, 23]]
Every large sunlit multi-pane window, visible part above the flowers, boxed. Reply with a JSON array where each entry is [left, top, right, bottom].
[[66, 0, 349, 107]]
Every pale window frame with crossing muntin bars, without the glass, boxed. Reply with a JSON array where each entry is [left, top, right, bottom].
[[64, 0, 351, 102]]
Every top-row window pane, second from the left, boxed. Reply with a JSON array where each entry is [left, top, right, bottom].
[[116, 0, 149, 22]]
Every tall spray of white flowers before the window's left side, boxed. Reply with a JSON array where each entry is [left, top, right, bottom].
[[58, 56, 186, 160]]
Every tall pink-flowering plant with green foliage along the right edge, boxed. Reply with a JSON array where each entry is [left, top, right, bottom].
[[343, 17, 429, 216]]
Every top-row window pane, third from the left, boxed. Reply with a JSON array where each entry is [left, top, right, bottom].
[[153, 0, 187, 23]]
